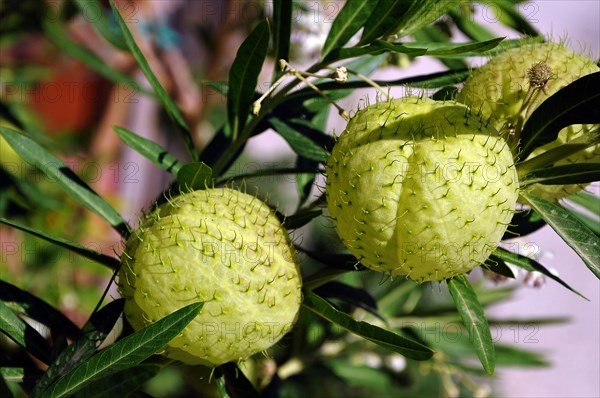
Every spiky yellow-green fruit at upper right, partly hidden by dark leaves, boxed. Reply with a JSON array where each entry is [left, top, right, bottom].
[[457, 43, 600, 200]]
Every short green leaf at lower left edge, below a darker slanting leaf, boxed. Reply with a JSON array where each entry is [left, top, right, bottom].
[[0, 301, 51, 364]]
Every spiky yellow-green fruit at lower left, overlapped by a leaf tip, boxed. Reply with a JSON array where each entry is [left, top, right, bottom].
[[119, 188, 301, 366]]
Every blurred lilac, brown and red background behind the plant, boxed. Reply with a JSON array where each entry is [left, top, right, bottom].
[[0, 0, 600, 397]]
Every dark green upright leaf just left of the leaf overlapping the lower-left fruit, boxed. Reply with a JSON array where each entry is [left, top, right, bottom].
[[31, 299, 125, 398]]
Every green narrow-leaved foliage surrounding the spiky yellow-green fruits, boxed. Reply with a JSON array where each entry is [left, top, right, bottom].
[[0, 0, 600, 397]]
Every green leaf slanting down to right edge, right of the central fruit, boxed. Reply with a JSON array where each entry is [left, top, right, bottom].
[[521, 192, 600, 279]]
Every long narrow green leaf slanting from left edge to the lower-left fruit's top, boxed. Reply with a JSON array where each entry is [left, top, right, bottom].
[[0, 126, 130, 237]]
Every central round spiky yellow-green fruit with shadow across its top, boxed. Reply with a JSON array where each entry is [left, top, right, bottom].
[[326, 97, 519, 282]]
